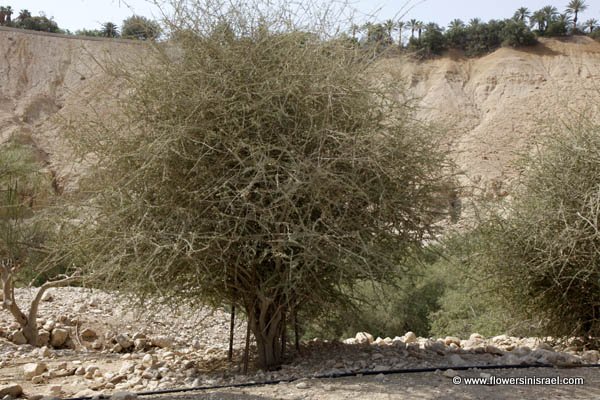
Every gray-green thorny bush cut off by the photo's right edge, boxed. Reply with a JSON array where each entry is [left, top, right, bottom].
[[484, 121, 600, 339]]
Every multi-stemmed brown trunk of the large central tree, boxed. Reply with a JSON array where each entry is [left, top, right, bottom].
[[248, 299, 284, 370]]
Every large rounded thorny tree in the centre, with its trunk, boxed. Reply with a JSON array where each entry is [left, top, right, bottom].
[[71, 0, 448, 367]]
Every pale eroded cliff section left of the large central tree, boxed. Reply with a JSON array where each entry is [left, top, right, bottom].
[[0, 28, 142, 190]]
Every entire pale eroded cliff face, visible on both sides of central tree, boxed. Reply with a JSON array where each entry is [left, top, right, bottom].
[[0, 29, 600, 197]]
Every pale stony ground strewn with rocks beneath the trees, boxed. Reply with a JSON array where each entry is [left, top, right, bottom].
[[0, 288, 600, 399]]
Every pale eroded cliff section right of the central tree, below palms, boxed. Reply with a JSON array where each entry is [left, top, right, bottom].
[[386, 36, 600, 197]]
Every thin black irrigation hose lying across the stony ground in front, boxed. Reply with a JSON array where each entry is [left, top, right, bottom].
[[64, 364, 600, 400]]
